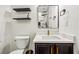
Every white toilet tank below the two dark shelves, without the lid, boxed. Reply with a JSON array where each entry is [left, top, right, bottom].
[[15, 36, 29, 49]]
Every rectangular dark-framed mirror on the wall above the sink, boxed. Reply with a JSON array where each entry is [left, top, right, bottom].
[[37, 5, 59, 29]]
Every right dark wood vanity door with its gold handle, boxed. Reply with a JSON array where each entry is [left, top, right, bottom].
[[56, 43, 73, 54]]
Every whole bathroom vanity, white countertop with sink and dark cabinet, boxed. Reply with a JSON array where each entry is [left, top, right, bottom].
[[33, 35, 75, 54]]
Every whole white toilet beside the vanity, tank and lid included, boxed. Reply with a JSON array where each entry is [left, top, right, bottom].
[[10, 36, 29, 54]]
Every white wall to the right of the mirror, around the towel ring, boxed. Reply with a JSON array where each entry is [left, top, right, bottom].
[[59, 5, 79, 53]]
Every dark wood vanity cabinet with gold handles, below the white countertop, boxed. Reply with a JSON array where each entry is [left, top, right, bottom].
[[35, 43, 73, 54]]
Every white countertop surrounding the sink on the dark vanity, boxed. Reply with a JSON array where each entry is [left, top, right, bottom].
[[33, 35, 75, 43]]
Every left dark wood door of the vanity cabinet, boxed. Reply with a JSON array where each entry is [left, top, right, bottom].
[[35, 43, 50, 54]]
